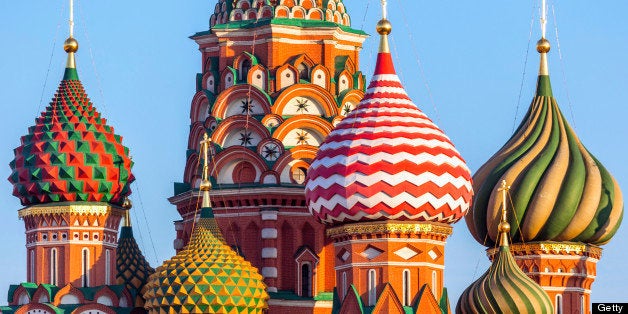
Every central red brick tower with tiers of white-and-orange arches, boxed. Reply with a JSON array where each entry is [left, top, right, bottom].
[[169, 0, 366, 313]]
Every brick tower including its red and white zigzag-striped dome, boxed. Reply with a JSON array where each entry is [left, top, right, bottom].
[[306, 5, 473, 313]]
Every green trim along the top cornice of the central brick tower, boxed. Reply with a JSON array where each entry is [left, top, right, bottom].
[[190, 18, 369, 39]]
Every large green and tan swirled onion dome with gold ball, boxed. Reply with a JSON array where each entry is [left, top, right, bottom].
[[467, 38, 623, 246]]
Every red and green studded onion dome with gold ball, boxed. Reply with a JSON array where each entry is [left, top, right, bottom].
[[9, 37, 135, 206]]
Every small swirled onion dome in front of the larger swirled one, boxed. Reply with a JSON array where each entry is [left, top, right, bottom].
[[456, 182, 554, 313]]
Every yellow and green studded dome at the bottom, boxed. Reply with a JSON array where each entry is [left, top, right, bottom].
[[144, 208, 269, 313]]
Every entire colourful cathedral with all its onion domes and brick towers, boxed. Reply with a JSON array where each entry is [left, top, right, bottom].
[[0, 0, 623, 314]]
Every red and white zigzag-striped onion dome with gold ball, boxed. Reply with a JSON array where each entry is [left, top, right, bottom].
[[305, 19, 473, 224]]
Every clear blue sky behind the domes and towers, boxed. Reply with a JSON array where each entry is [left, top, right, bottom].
[[0, 0, 628, 306]]
